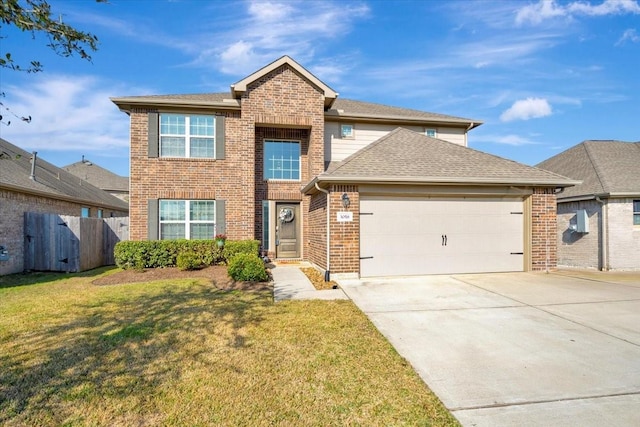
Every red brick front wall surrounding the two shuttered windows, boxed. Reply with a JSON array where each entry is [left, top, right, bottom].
[[129, 110, 255, 240]]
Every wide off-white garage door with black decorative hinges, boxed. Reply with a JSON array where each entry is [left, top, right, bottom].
[[360, 196, 524, 277]]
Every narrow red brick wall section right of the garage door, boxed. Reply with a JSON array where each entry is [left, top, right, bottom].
[[531, 188, 558, 271]]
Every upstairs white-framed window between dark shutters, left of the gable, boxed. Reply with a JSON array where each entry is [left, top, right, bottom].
[[160, 114, 216, 158]]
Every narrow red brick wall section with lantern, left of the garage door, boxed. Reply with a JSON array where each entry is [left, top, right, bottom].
[[329, 185, 360, 273]]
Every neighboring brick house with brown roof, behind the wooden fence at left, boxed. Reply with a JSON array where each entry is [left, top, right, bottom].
[[0, 138, 129, 275]]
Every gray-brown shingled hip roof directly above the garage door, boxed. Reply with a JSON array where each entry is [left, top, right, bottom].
[[303, 128, 578, 192]]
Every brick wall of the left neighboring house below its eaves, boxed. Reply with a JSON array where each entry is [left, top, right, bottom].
[[0, 190, 128, 275]]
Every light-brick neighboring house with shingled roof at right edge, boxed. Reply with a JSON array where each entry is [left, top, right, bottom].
[[538, 141, 640, 270]]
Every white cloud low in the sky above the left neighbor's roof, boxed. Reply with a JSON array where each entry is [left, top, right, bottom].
[[1, 75, 129, 152]]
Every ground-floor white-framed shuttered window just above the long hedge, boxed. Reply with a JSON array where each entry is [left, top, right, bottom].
[[158, 200, 216, 240]]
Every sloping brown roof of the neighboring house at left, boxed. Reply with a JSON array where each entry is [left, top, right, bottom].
[[0, 138, 129, 211]]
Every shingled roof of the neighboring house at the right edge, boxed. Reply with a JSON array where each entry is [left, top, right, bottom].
[[537, 141, 640, 200]]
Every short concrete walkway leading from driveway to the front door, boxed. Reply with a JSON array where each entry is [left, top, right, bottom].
[[271, 263, 349, 302]]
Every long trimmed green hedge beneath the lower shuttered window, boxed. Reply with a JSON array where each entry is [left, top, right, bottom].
[[114, 239, 260, 270]]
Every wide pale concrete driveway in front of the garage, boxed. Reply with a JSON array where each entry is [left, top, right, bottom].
[[340, 271, 640, 427]]
